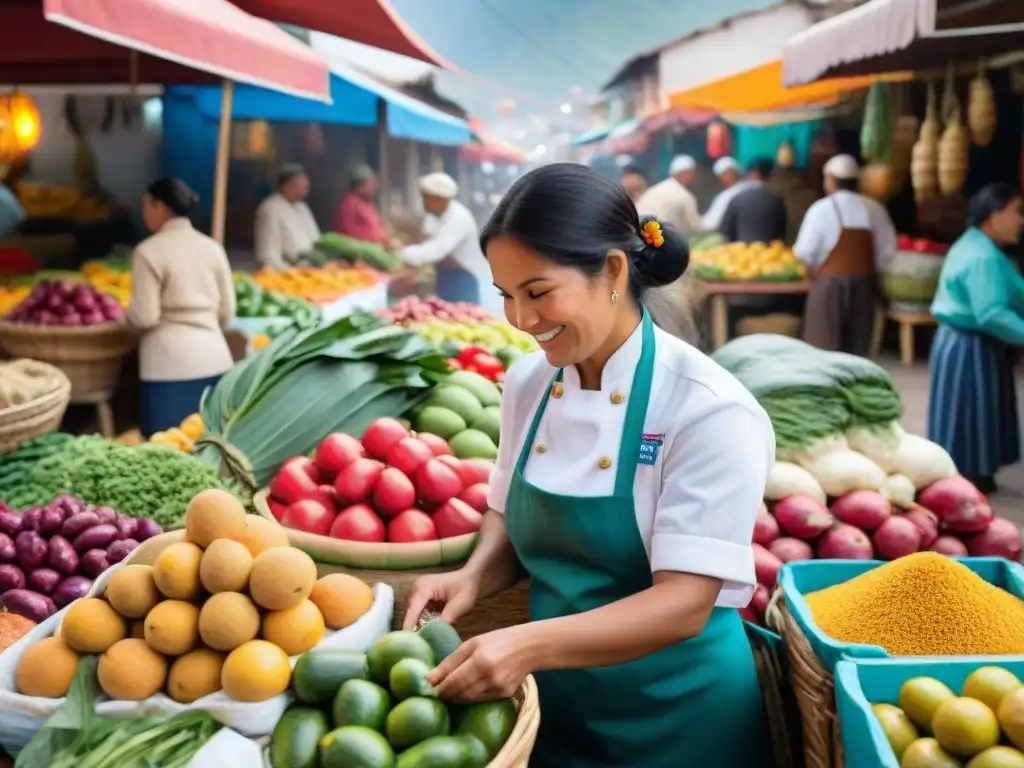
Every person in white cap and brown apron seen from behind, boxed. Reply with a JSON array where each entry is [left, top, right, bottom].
[[793, 155, 896, 357]]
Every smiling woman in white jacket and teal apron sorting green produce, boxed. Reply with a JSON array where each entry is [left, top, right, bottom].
[[406, 163, 775, 768]]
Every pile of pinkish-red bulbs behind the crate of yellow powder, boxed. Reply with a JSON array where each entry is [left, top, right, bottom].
[[742, 476, 1021, 624]]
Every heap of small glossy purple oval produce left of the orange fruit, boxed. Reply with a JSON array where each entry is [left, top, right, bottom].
[[0, 496, 164, 623]]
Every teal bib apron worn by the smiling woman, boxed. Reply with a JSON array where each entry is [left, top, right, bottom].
[[505, 312, 772, 768]]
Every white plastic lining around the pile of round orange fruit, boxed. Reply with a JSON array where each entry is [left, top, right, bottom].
[[0, 580, 394, 755]]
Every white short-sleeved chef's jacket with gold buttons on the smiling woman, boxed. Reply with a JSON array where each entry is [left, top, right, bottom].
[[487, 327, 775, 608]]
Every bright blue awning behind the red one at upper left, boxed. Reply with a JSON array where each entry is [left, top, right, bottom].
[[167, 63, 472, 145]]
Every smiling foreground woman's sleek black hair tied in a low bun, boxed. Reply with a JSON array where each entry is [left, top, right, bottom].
[[480, 163, 690, 302]]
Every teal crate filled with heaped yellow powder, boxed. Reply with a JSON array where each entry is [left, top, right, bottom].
[[778, 557, 1024, 670]]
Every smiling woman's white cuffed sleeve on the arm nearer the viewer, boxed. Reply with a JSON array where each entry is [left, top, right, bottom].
[[650, 400, 775, 607]]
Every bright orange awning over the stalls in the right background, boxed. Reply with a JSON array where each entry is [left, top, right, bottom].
[[669, 58, 913, 113]]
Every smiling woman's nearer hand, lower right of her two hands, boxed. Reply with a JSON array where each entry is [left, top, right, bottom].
[[427, 624, 536, 702]]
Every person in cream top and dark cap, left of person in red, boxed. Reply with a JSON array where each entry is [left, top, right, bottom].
[[255, 163, 321, 269]]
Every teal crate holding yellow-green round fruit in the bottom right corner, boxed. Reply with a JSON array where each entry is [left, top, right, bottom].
[[836, 655, 1024, 768]]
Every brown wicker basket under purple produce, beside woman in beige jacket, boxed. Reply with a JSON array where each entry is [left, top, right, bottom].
[[0, 321, 137, 399]]
